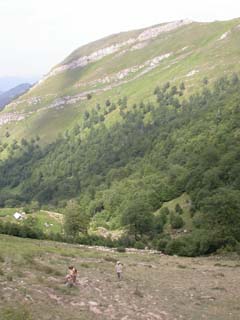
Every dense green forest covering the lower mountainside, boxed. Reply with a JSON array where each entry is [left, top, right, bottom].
[[0, 74, 240, 255]]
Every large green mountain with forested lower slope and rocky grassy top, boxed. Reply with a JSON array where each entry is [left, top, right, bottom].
[[0, 19, 240, 256]]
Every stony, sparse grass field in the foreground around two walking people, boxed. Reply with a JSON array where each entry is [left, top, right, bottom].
[[0, 235, 240, 320]]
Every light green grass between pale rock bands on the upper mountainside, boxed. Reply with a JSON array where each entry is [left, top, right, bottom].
[[0, 19, 240, 143]]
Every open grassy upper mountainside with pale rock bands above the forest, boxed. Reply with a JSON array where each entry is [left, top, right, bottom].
[[0, 19, 240, 143]]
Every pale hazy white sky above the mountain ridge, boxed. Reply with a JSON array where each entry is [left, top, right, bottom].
[[0, 0, 240, 77]]
